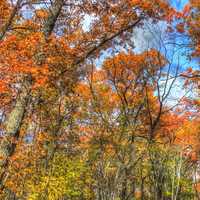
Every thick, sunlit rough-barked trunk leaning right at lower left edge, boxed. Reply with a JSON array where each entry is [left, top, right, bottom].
[[0, 76, 32, 189]]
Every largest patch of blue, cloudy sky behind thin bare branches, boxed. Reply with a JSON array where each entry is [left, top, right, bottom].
[[132, 20, 193, 107]]
